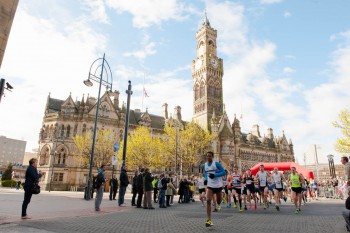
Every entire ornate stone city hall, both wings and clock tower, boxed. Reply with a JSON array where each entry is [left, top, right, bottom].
[[39, 17, 294, 190]]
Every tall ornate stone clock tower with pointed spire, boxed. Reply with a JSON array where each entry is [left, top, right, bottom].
[[192, 14, 224, 131]]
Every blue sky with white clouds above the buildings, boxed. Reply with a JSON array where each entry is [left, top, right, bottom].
[[0, 0, 350, 164]]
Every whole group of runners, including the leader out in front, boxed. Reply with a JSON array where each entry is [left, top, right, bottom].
[[198, 151, 306, 227]]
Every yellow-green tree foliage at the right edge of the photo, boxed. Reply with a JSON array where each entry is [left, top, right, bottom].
[[333, 110, 350, 154]]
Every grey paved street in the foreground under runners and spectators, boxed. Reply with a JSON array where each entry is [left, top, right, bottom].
[[0, 188, 346, 233]]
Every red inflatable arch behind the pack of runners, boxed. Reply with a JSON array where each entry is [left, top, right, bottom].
[[250, 162, 314, 179]]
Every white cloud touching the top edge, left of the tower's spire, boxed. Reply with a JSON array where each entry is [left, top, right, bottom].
[[106, 0, 185, 28]]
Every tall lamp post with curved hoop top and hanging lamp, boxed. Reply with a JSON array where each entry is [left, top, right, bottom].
[[84, 54, 113, 200]]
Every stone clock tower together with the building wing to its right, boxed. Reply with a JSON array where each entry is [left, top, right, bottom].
[[192, 17, 294, 171]]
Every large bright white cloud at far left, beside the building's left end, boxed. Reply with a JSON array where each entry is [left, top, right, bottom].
[[0, 4, 106, 151]]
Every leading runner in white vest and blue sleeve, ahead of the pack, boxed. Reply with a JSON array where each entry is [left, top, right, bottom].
[[204, 151, 226, 227]]
